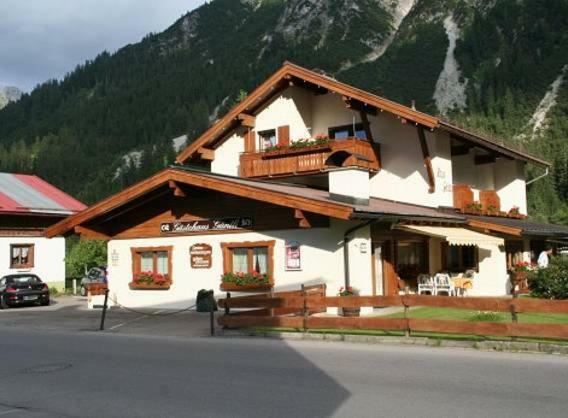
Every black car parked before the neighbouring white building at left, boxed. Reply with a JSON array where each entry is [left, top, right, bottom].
[[0, 274, 49, 309]]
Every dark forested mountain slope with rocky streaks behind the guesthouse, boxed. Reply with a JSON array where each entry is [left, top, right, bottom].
[[0, 0, 568, 220]]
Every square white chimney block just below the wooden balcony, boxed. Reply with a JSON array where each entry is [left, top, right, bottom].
[[328, 167, 370, 205]]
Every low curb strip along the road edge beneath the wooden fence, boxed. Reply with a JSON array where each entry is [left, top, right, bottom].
[[221, 330, 568, 355]]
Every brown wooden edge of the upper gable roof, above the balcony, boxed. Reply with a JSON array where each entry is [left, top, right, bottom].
[[177, 62, 551, 167]]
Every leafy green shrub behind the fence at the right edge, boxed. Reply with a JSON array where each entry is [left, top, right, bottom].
[[528, 257, 568, 299]]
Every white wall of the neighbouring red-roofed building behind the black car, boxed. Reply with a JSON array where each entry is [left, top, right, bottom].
[[0, 237, 65, 289]]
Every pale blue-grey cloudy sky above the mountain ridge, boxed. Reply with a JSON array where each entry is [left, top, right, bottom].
[[0, 0, 204, 91]]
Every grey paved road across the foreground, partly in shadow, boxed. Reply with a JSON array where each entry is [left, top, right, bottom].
[[0, 324, 568, 418]]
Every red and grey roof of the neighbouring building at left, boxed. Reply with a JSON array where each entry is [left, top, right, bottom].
[[0, 173, 86, 216]]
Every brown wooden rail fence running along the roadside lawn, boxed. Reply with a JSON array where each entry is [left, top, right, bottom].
[[218, 291, 568, 339]]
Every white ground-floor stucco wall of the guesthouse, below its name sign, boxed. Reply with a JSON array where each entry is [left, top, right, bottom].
[[108, 220, 371, 309]]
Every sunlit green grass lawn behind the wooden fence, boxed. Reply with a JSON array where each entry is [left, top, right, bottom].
[[386, 307, 568, 324]]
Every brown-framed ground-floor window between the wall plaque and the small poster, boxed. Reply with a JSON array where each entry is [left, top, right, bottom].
[[221, 241, 274, 280]]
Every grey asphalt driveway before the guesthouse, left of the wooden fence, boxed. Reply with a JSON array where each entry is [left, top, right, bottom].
[[0, 296, 217, 337]]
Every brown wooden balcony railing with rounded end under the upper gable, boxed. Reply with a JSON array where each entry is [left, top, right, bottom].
[[240, 138, 380, 178]]
